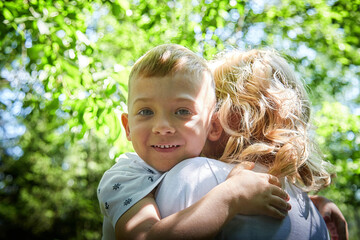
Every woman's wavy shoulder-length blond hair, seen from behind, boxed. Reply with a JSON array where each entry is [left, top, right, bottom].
[[213, 50, 330, 191]]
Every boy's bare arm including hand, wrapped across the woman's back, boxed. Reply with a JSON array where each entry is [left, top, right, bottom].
[[115, 166, 289, 239]]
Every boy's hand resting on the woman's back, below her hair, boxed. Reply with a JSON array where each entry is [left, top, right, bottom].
[[226, 163, 291, 219]]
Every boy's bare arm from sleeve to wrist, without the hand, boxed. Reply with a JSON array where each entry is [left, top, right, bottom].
[[115, 188, 231, 240]]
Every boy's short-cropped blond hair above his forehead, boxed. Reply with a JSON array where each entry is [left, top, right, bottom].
[[128, 44, 215, 101]]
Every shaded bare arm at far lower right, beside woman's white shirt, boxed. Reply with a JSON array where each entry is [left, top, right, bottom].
[[310, 195, 349, 240]]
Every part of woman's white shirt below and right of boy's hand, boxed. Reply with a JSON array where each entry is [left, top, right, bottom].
[[217, 183, 329, 240]]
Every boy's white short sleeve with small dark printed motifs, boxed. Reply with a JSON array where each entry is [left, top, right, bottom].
[[97, 153, 165, 228]]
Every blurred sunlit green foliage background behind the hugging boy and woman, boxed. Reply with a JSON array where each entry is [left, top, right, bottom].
[[0, 0, 360, 239]]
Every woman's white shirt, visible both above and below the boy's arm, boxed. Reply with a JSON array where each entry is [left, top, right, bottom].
[[156, 157, 329, 240]]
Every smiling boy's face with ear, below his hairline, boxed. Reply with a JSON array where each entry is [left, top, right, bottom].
[[122, 72, 215, 171]]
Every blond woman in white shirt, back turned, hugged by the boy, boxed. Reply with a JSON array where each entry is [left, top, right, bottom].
[[156, 50, 347, 239]]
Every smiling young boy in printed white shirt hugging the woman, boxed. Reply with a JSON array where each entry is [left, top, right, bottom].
[[98, 44, 289, 239]]
